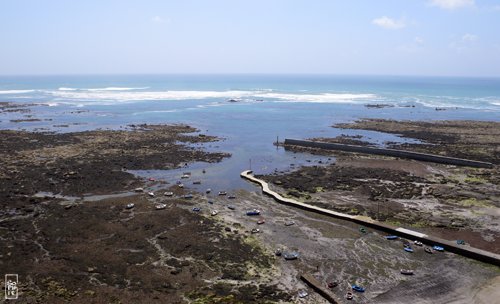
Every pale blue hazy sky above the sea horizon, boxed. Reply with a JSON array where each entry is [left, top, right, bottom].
[[0, 0, 500, 77]]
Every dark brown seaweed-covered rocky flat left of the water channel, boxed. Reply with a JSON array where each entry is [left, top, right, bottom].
[[0, 125, 289, 303]]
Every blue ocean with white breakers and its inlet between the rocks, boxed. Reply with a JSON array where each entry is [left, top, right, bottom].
[[0, 75, 500, 189]]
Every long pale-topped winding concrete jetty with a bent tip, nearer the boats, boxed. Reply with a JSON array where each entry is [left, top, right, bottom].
[[240, 170, 500, 266]]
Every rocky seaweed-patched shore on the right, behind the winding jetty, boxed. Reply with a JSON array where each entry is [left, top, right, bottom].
[[262, 119, 500, 253]]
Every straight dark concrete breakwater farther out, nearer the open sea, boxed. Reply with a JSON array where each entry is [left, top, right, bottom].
[[284, 138, 493, 168]]
